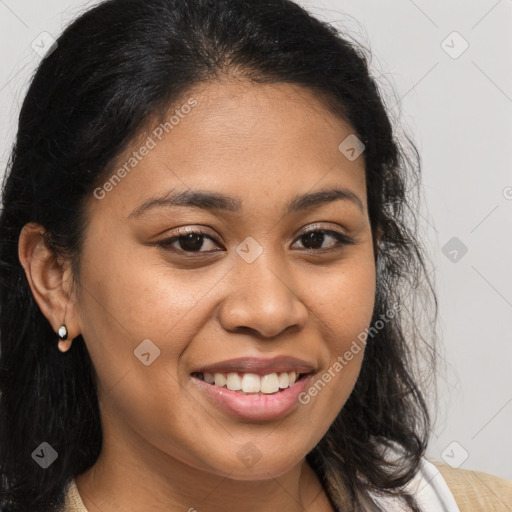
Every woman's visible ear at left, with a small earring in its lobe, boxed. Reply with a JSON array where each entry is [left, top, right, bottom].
[[18, 222, 80, 352]]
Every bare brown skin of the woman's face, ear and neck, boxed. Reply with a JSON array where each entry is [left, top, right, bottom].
[[19, 81, 376, 512]]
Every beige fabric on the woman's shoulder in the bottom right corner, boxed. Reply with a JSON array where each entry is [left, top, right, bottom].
[[431, 461, 512, 512]]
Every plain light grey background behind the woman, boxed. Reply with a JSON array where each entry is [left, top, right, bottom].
[[0, 0, 512, 480]]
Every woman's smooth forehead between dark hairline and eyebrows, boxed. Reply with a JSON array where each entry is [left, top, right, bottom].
[[89, 82, 366, 217]]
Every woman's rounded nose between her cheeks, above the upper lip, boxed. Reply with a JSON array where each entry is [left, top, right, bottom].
[[219, 252, 308, 338]]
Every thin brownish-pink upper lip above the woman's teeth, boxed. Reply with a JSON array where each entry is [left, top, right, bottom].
[[193, 356, 316, 375]]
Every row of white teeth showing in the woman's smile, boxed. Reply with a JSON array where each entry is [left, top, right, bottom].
[[191, 371, 309, 395]]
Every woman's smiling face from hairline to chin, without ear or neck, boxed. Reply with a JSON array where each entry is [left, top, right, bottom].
[[75, 82, 375, 480]]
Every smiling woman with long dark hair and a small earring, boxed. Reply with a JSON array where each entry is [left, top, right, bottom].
[[0, 0, 510, 512]]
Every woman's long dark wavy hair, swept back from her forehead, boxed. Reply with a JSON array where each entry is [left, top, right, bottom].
[[0, 0, 437, 512]]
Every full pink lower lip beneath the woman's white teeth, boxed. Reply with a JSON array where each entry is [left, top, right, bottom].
[[192, 373, 313, 420]]
